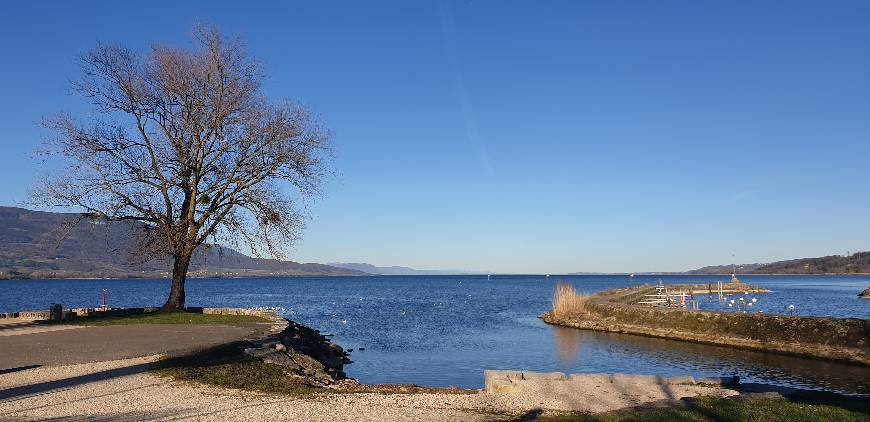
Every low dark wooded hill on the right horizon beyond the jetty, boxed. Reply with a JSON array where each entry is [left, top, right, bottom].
[[689, 252, 870, 274]]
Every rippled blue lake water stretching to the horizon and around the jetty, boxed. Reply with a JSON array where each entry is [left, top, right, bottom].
[[0, 275, 870, 394]]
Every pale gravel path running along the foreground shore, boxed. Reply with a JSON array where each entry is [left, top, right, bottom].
[[0, 356, 736, 422]]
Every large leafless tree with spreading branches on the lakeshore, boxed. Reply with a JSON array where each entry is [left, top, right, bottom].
[[34, 26, 331, 310]]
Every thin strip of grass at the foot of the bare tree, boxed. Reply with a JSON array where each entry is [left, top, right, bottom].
[[63, 312, 269, 325]]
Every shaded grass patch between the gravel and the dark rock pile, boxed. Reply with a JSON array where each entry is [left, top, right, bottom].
[[153, 342, 329, 395]]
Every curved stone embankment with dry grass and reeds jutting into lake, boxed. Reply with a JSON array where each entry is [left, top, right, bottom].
[[540, 282, 870, 366]]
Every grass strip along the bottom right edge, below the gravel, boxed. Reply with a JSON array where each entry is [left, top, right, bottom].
[[518, 397, 870, 422]]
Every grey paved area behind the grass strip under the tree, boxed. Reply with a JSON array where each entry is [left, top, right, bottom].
[[0, 323, 271, 374]]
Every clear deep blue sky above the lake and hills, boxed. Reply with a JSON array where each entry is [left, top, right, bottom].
[[0, 0, 870, 273]]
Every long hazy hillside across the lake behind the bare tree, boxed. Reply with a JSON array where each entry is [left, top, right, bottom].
[[0, 207, 367, 278]]
